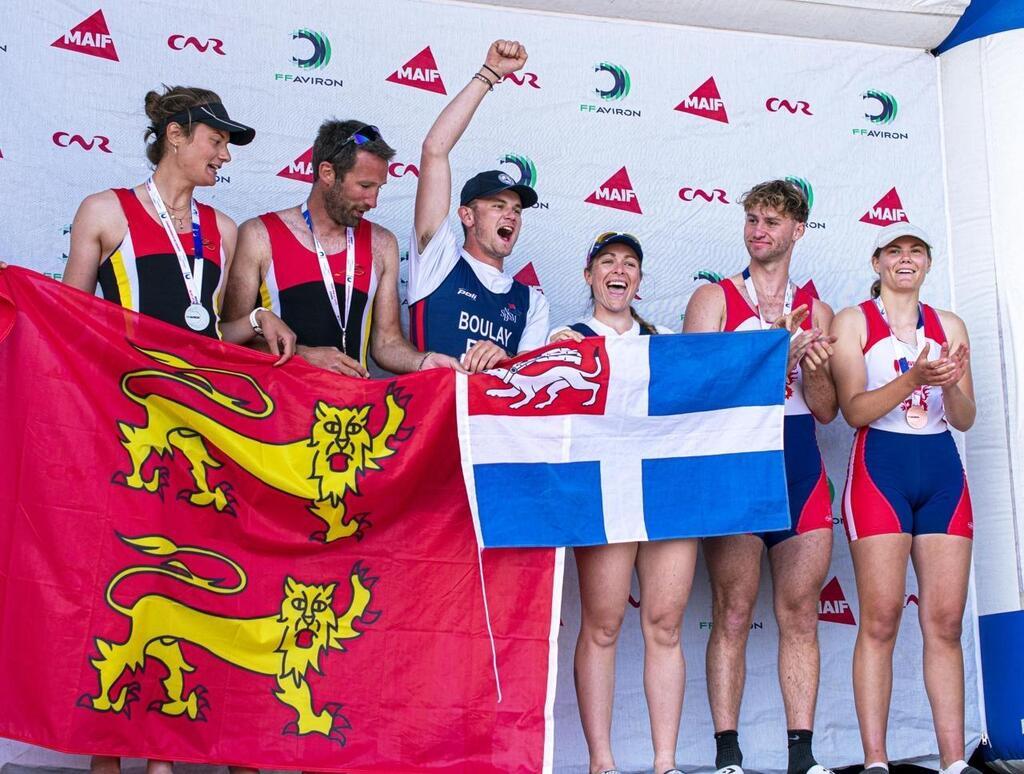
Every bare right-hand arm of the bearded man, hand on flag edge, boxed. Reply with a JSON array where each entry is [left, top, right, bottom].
[[370, 224, 459, 374]]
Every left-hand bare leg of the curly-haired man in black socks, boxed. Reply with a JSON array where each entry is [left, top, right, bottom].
[[703, 534, 764, 733]]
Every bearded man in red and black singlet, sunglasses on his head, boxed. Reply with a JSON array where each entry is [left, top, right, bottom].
[[224, 121, 458, 378]]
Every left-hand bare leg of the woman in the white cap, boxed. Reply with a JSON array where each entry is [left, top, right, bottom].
[[850, 534, 910, 763]]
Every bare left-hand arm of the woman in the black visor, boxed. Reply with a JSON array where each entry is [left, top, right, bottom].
[[63, 190, 128, 293]]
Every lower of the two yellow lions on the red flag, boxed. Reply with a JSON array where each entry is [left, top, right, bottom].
[[78, 535, 380, 744]]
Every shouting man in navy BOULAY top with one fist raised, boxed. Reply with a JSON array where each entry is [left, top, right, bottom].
[[409, 40, 548, 372]]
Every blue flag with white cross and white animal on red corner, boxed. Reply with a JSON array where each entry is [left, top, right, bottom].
[[456, 331, 790, 548]]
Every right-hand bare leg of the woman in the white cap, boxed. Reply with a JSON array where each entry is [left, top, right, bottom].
[[910, 534, 972, 768]]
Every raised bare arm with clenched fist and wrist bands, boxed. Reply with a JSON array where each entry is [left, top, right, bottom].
[[413, 40, 526, 250]]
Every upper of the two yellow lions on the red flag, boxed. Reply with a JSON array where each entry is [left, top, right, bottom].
[[112, 347, 412, 543]]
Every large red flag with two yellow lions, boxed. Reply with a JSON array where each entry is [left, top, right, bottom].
[[0, 268, 557, 772]]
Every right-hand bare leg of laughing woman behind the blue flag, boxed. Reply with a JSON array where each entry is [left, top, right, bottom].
[[637, 540, 697, 772]]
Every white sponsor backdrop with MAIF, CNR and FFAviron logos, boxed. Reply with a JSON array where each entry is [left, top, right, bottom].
[[0, 0, 980, 771]]
